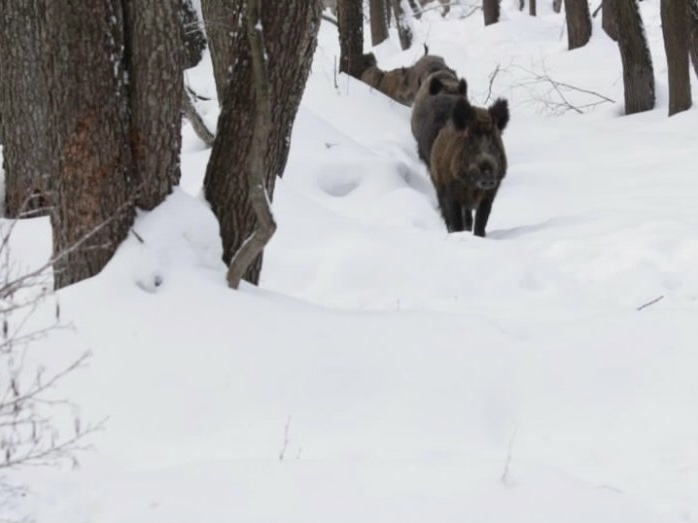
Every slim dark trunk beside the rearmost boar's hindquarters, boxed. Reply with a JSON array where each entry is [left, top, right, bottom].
[[337, 0, 364, 79]]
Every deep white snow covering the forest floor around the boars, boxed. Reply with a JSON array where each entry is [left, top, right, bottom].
[[3, 0, 698, 523]]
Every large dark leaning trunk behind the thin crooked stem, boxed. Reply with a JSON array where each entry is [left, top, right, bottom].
[[204, 0, 320, 283]]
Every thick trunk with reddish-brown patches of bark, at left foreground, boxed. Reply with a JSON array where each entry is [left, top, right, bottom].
[[41, 0, 134, 288]]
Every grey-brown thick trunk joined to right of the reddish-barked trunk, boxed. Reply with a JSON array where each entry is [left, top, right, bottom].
[[123, 0, 183, 210]]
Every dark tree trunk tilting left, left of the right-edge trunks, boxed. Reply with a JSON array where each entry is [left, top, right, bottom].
[[613, 0, 655, 114]]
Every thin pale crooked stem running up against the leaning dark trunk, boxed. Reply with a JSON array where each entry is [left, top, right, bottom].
[[227, 0, 276, 289]]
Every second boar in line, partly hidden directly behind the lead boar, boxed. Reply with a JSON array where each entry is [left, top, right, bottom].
[[410, 71, 468, 167]]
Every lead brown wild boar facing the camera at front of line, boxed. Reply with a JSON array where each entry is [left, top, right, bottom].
[[430, 97, 509, 237]]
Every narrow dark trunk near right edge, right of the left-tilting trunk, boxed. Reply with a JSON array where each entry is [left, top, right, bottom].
[[660, 0, 691, 116]]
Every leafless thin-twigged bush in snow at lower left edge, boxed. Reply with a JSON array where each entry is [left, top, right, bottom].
[[0, 203, 98, 510]]
